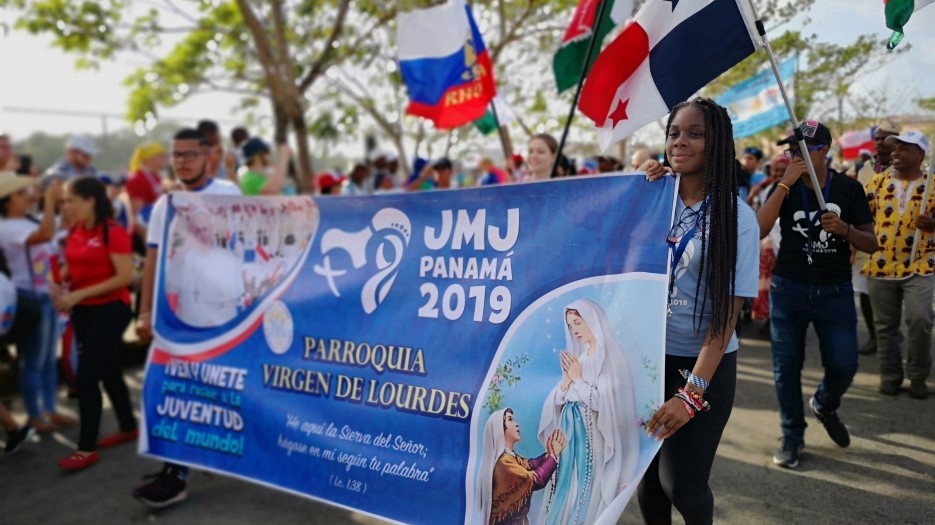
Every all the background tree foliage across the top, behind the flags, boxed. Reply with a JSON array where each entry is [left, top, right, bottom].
[[0, 0, 908, 168]]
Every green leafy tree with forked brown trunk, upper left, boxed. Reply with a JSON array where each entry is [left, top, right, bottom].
[[0, 0, 406, 191]]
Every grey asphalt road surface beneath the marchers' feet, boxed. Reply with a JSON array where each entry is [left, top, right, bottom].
[[0, 324, 935, 525]]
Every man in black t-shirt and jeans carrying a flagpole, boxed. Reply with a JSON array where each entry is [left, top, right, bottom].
[[757, 120, 877, 468]]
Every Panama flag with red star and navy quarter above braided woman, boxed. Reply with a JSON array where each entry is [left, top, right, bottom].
[[579, 0, 760, 149]]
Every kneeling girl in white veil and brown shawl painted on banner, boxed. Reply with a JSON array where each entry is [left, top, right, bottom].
[[477, 408, 565, 525]]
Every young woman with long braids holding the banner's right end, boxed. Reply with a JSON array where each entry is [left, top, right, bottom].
[[638, 98, 759, 525]]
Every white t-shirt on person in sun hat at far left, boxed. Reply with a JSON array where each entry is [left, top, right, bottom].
[[0, 218, 58, 293]]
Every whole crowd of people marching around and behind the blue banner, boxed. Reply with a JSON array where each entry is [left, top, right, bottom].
[[0, 107, 935, 523]]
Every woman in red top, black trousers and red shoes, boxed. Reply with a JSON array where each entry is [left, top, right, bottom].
[[54, 177, 139, 470]]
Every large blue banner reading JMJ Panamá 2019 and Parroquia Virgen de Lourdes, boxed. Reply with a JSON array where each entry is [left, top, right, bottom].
[[140, 174, 675, 524]]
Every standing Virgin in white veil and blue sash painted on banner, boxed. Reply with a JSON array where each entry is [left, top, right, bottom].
[[538, 299, 640, 525]]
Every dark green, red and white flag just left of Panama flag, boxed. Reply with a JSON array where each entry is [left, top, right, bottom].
[[552, 0, 633, 93]]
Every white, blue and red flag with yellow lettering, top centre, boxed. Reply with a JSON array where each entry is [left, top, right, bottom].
[[397, 0, 497, 129]]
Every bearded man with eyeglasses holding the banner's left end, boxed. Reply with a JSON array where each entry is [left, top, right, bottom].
[[133, 128, 240, 508]]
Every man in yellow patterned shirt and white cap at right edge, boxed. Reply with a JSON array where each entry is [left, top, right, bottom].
[[863, 131, 935, 399]]
